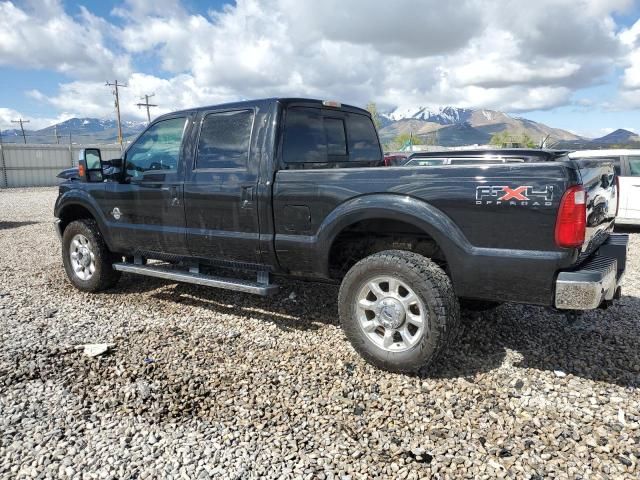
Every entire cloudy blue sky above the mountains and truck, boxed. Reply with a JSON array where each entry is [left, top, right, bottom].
[[0, 0, 640, 137]]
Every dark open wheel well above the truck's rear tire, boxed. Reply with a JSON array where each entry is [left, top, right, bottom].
[[329, 219, 448, 279]]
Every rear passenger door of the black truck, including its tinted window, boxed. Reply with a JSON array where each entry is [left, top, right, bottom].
[[184, 109, 260, 264]]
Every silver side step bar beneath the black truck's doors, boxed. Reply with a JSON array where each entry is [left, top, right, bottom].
[[113, 263, 278, 296]]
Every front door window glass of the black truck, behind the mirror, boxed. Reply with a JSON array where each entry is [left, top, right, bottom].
[[125, 117, 187, 179]]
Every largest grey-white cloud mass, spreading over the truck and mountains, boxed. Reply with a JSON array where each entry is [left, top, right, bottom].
[[107, 0, 628, 111]]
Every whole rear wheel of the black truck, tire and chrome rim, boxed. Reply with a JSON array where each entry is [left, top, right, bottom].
[[338, 250, 460, 372]]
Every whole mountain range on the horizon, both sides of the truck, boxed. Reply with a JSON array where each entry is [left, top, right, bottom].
[[2, 107, 640, 149]]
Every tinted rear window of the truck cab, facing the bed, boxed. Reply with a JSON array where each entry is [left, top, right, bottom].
[[282, 106, 383, 168]]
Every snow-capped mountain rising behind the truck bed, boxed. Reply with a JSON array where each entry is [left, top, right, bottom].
[[380, 107, 582, 146]]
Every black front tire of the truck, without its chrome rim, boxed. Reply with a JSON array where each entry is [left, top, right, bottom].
[[62, 219, 121, 292]]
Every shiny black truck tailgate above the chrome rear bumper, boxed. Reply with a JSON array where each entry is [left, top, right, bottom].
[[573, 158, 618, 259]]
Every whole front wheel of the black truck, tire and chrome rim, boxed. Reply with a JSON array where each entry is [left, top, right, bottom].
[[62, 219, 120, 292]]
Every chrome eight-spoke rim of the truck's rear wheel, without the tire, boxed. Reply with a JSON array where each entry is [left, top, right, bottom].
[[356, 275, 428, 352]]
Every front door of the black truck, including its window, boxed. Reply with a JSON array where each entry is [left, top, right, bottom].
[[106, 116, 188, 255]]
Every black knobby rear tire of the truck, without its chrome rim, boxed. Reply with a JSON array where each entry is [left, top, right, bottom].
[[338, 250, 460, 372]]
